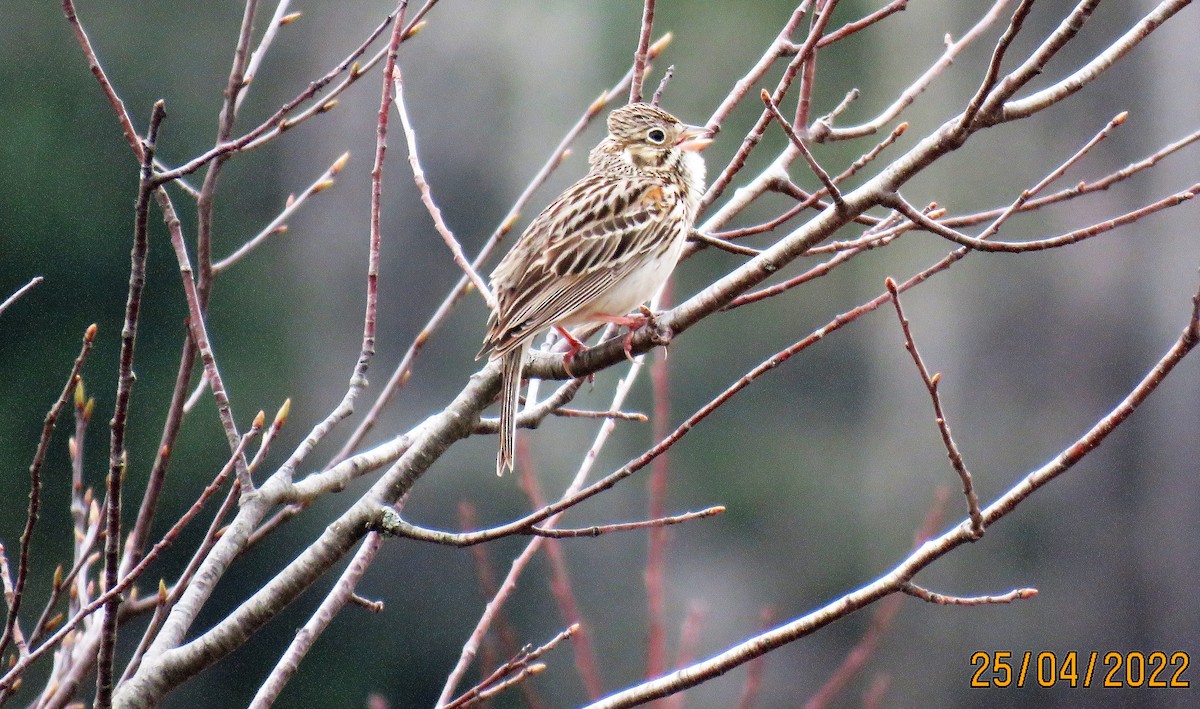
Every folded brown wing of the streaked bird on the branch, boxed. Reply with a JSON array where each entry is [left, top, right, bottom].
[[480, 174, 683, 355]]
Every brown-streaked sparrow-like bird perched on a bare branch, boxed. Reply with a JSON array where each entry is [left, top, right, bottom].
[[475, 103, 713, 475]]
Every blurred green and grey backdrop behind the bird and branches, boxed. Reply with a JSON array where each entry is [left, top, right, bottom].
[[0, 0, 1200, 708]]
